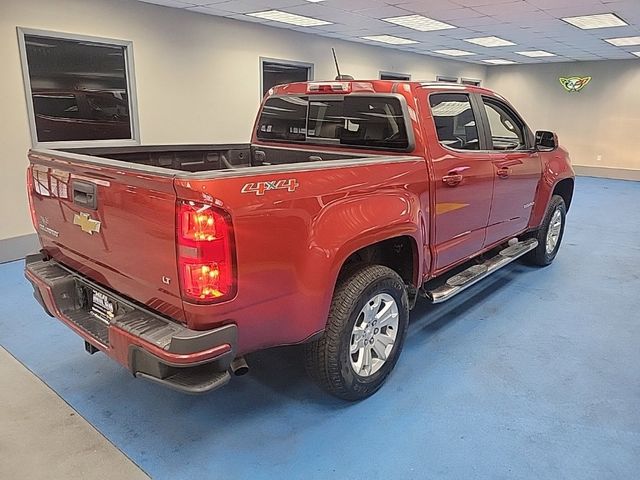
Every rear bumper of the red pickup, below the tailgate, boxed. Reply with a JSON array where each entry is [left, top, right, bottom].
[[25, 255, 237, 393]]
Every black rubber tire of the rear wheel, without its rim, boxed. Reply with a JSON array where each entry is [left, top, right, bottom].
[[305, 265, 409, 401]]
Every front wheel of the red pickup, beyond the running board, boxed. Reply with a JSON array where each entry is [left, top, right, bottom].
[[524, 195, 567, 267]]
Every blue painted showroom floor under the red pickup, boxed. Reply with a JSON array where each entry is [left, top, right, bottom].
[[0, 178, 640, 480]]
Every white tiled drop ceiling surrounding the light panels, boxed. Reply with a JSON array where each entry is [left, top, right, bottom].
[[140, 0, 640, 63]]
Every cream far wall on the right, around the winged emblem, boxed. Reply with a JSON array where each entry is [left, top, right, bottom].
[[485, 59, 640, 173]]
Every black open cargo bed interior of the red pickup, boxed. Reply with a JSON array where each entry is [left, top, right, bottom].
[[62, 144, 371, 173]]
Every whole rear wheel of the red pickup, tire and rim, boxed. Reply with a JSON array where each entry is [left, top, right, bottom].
[[306, 265, 409, 401]]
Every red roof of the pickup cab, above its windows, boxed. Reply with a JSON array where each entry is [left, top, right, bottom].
[[268, 80, 497, 95]]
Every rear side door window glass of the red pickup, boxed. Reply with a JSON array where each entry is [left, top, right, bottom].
[[429, 93, 480, 150]]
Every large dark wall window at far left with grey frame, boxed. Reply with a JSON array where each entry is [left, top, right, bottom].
[[19, 29, 139, 146]]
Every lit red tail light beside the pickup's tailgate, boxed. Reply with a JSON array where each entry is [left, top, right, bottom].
[[177, 201, 236, 303]]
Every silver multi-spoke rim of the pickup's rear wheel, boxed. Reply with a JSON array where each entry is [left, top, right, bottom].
[[349, 293, 399, 377]]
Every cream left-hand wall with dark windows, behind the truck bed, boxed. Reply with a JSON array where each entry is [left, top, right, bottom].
[[0, 0, 486, 240]]
